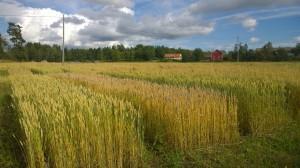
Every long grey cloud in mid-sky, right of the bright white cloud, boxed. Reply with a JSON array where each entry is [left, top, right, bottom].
[[79, 8, 214, 45]]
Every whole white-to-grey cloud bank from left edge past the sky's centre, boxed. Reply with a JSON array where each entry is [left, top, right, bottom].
[[0, 0, 218, 47]]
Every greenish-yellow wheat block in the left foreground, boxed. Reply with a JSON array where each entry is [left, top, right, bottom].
[[10, 75, 143, 168]]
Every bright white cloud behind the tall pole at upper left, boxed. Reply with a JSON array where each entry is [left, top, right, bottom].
[[0, 0, 91, 44]]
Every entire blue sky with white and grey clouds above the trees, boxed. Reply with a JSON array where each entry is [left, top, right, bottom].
[[0, 0, 300, 50]]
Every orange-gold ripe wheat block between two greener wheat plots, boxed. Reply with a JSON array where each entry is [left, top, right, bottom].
[[60, 75, 238, 151]]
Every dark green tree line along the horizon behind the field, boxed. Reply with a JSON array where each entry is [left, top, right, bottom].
[[0, 23, 300, 62]]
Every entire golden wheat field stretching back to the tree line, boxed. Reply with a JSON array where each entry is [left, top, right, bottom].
[[0, 63, 300, 168]]
